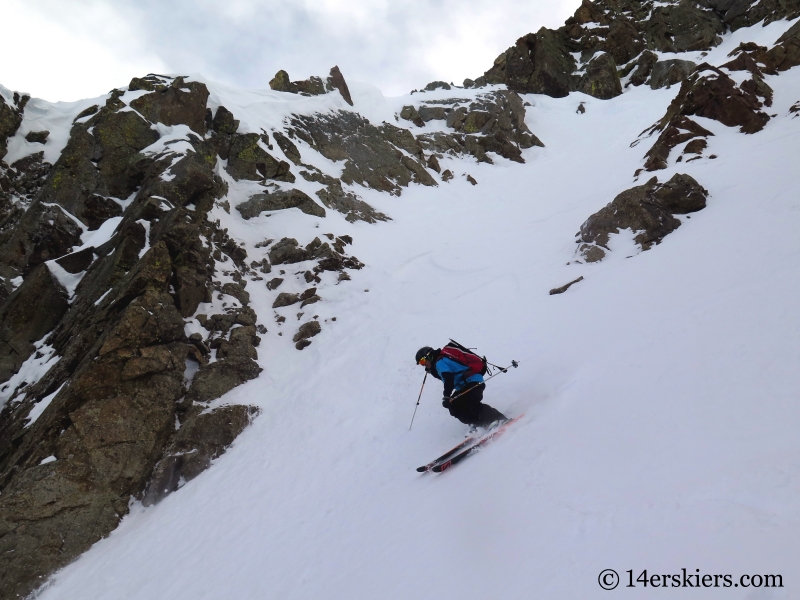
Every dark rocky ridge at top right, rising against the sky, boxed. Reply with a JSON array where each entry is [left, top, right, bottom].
[[472, 0, 800, 99]]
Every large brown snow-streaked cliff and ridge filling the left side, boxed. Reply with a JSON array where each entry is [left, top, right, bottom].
[[0, 57, 540, 597]]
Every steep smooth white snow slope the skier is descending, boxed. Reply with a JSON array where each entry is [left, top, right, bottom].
[[26, 23, 800, 600]]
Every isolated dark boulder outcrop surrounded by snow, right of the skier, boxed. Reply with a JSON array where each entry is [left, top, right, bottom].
[[579, 174, 708, 262]]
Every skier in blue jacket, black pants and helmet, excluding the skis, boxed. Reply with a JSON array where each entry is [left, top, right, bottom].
[[416, 346, 508, 431]]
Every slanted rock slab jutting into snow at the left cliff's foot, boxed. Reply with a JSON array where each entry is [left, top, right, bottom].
[[142, 405, 256, 506]]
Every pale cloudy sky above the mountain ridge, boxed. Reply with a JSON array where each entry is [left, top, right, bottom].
[[0, 0, 580, 101]]
